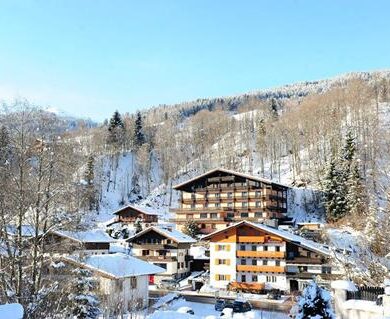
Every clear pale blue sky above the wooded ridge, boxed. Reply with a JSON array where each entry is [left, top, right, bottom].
[[0, 0, 390, 120]]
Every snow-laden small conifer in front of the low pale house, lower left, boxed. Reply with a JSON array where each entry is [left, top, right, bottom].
[[69, 269, 100, 319]]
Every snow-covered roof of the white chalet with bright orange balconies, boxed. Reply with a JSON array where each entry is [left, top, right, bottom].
[[204, 220, 331, 256]]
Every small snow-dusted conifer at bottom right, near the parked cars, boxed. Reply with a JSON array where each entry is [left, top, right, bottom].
[[295, 281, 336, 319]]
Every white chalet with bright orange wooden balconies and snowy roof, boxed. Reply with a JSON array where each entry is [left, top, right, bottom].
[[205, 221, 339, 291]]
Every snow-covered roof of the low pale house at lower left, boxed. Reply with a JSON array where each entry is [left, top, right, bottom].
[[64, 253, 165, 279]]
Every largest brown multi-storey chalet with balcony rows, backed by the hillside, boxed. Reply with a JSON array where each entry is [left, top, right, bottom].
[[171, 169, 288, 234]]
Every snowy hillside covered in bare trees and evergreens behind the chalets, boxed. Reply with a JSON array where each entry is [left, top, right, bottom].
[[0, 72, 390, 313]]
